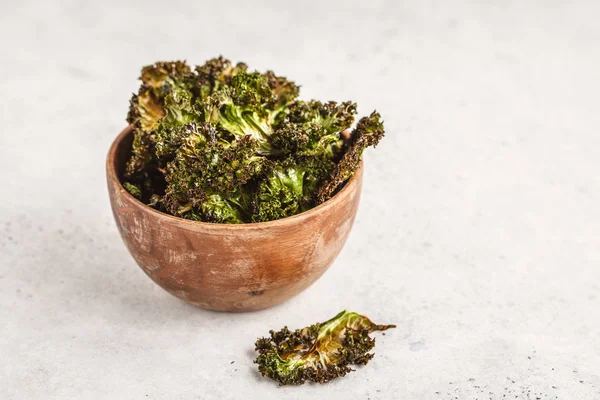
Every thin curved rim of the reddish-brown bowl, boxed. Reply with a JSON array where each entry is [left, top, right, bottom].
[[106, 125, 363, 230]]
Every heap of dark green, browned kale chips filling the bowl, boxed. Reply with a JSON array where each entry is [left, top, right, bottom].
[[124, 57, 384, 223]]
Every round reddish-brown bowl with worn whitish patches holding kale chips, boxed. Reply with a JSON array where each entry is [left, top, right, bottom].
[[106, 127, 363, 311]]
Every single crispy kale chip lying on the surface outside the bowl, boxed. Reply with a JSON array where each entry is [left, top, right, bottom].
[[254, 311, 396, 385]]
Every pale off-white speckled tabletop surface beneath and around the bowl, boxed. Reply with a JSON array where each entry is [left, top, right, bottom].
[[0, 0, 600, 400]]
